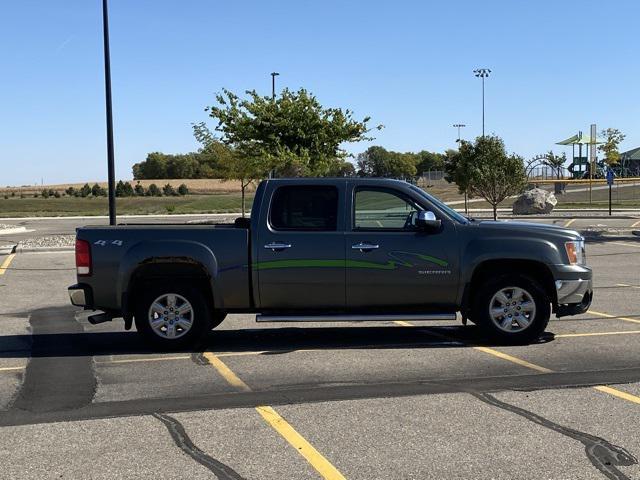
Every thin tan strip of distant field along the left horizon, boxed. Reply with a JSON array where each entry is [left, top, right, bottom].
[[0, 178, 255, 195]]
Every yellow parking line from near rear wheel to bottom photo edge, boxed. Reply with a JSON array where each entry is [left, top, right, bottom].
[[203, 352, 345, 480]]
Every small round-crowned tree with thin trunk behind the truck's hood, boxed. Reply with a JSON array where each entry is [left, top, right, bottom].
[[453, 135, 527, 220]]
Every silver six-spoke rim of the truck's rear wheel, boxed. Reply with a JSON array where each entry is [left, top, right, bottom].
[[148, 293, 193, 340]]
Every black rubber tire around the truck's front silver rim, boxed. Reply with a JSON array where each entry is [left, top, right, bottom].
[[473, 274, 551, 344]]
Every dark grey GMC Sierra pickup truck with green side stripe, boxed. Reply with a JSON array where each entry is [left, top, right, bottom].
[[69, 178, 593, 349]]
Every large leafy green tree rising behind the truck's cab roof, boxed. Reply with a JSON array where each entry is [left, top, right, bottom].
[[205, 89, 382, 180]]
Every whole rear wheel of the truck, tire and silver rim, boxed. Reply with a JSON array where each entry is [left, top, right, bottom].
[[135, 283, 210, 350]]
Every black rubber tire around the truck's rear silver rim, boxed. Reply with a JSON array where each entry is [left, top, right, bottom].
[[135, 282, 210, 350]]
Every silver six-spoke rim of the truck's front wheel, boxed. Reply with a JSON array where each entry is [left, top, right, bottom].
[[489, 287, 536, 333]]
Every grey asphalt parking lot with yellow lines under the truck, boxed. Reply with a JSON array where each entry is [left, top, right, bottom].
[[0, 228, 640, 479]]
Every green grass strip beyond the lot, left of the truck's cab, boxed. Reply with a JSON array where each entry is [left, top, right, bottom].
[[0, 193, 253, 218]]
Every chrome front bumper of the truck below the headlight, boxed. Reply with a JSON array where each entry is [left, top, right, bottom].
[[555, 265, 593, 317]]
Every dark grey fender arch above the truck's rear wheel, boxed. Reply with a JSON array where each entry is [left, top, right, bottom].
[[116, 240, 223, 309]]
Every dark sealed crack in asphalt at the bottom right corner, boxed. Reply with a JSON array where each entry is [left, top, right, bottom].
[[471, 392, 638, 480]]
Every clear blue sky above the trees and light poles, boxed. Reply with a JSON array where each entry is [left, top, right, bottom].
[[0, 0, 640, 185]]
